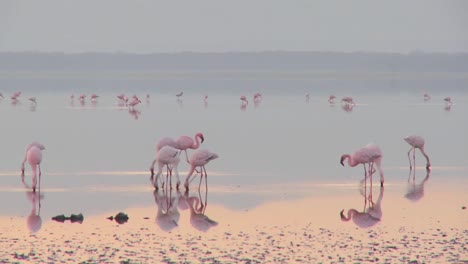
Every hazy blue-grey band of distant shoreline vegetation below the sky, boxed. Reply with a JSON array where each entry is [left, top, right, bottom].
[[0, 51, 468, 73]]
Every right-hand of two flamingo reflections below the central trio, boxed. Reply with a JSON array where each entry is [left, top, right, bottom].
[[185, 189, 218, 232]]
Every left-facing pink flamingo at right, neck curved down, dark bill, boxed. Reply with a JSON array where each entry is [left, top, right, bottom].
[[340, 144, 384, 186]]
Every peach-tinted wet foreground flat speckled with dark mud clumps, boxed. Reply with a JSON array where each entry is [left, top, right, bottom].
[[0, 176, 468, 263]]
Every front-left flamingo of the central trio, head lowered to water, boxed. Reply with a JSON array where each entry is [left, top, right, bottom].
[[150, 146, 180, 190]]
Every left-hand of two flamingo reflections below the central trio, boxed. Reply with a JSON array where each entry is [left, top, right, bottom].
[[153, 189, 180, 232]]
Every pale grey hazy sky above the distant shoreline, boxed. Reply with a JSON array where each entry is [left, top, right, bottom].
[[0, 0, 468, 53]]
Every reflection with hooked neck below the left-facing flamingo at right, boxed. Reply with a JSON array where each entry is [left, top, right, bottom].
[[340, 186, 384, 228]]
